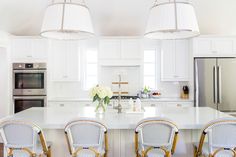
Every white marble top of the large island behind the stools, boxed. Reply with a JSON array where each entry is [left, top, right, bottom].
[[1, 107, 230, 129]]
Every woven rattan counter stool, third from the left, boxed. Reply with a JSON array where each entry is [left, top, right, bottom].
[[135, 117, 178, 157]]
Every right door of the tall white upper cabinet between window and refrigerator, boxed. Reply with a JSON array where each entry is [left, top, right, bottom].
[[174, 40, 190, 81]]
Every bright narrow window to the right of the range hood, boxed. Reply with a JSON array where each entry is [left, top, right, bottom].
[[143, 50, 156, 89]]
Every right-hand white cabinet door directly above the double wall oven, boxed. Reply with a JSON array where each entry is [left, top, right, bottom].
[[31, 39, 48, 59]]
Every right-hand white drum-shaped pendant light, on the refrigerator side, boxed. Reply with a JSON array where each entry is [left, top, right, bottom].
[[145, 0, 200, 39]]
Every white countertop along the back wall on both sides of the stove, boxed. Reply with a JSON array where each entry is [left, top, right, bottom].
[[48, 97, 193, 102]]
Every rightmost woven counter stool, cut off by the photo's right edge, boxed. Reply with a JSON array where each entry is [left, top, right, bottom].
[[194, 118, 236, 157]]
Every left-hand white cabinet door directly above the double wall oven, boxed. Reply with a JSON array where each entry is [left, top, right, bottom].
[[11, 39, 33, 59]]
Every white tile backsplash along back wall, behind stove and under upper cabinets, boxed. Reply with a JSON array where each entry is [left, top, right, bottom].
[[48, 67, 193, 99]]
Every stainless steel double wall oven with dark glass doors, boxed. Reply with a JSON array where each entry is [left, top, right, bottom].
[[13, 63, 47, 113]]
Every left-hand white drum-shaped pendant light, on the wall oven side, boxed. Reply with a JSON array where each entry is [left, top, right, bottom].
[[40, 0, 94, 40]]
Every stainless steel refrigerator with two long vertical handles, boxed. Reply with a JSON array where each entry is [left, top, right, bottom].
[[194, 58, 236, 112]]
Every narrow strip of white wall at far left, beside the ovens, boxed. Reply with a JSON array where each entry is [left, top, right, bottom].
[[0, 47, 9, 118]]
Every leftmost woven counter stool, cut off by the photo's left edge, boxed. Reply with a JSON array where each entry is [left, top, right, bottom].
[[0, 120, 51, 157]]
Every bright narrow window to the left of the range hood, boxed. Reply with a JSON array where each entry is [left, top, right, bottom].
[[84, 50, 98, 90]]
